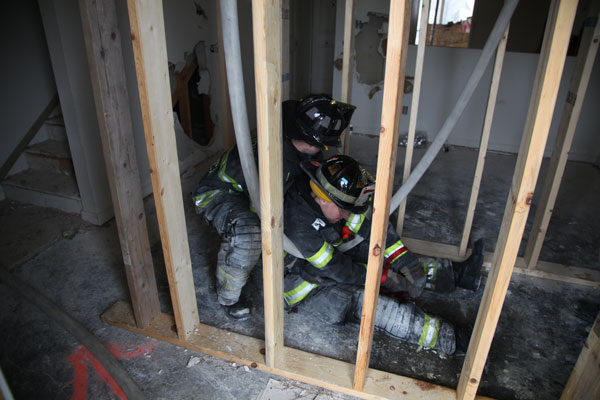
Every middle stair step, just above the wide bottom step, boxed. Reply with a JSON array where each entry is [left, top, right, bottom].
[[25, 140, 75, 176]]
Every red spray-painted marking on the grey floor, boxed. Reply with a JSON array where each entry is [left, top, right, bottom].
[[68, 341, 158, 400]]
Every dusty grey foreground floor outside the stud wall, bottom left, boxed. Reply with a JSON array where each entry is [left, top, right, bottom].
[[0, 201, 356, 400]]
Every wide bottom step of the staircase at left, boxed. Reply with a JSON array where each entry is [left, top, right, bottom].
[[2, 169, 81, 213]]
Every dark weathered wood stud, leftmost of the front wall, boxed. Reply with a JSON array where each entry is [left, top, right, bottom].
[[79, 0, 160, 328]]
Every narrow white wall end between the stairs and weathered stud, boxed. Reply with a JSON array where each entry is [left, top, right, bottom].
[[39, 0, 113, 225]]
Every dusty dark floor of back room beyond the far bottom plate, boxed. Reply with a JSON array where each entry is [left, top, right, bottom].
[[350, 135, 600, 269]]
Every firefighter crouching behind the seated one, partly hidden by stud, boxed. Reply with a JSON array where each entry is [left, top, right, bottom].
[[192, 94, 355, 320]]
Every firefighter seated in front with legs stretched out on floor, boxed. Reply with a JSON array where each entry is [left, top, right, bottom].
[[284, 155, 483, 354]]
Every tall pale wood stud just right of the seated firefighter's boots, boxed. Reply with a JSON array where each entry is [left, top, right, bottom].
[[457, 0, 577, 399]]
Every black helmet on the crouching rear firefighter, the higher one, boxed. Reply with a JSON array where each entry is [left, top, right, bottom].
[[282, 94, 356, 149]]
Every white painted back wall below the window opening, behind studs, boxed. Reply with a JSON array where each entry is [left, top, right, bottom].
[[333, 0, 600, 163]]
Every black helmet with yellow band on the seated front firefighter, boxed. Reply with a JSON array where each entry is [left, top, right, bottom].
[[301, 155, 375, 214]]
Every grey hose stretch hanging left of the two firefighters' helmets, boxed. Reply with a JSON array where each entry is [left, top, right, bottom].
[[220, 0, 302, 258]]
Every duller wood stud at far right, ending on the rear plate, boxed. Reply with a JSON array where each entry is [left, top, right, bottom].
[[524, 1, 600, 269]]
